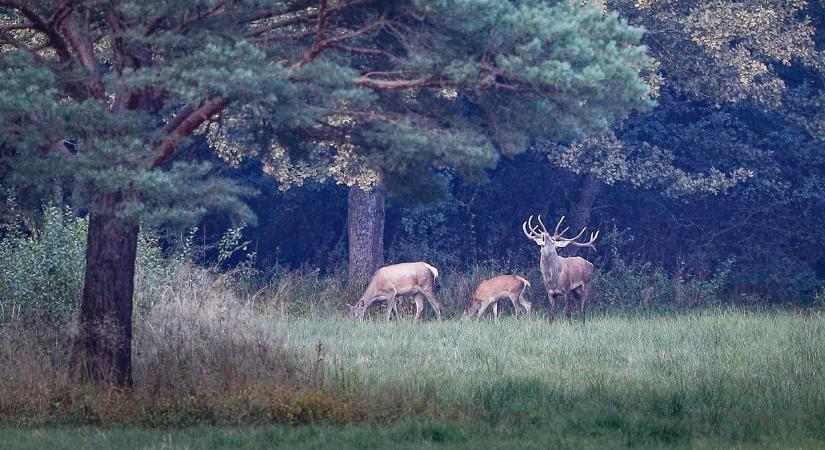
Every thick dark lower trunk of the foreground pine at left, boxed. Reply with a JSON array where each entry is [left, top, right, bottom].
[[74, 196, 139, 387]]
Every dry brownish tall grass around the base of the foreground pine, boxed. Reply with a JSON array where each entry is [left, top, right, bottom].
[[0, 266, 352, 426]]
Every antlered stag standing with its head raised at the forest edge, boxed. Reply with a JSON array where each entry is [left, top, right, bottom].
[[521, 215, 599, 322]]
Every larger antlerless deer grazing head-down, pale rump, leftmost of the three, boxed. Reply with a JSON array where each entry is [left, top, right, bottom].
[[347, 262, 441, 320]]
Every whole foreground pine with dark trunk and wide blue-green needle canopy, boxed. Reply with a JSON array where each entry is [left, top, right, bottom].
[[0, 0, 650, 385]]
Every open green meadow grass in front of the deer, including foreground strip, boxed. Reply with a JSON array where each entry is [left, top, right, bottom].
[[0, 312, 825, 449]]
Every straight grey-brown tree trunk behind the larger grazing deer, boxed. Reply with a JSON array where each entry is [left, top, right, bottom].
[[347, 186, 384, 282]]
